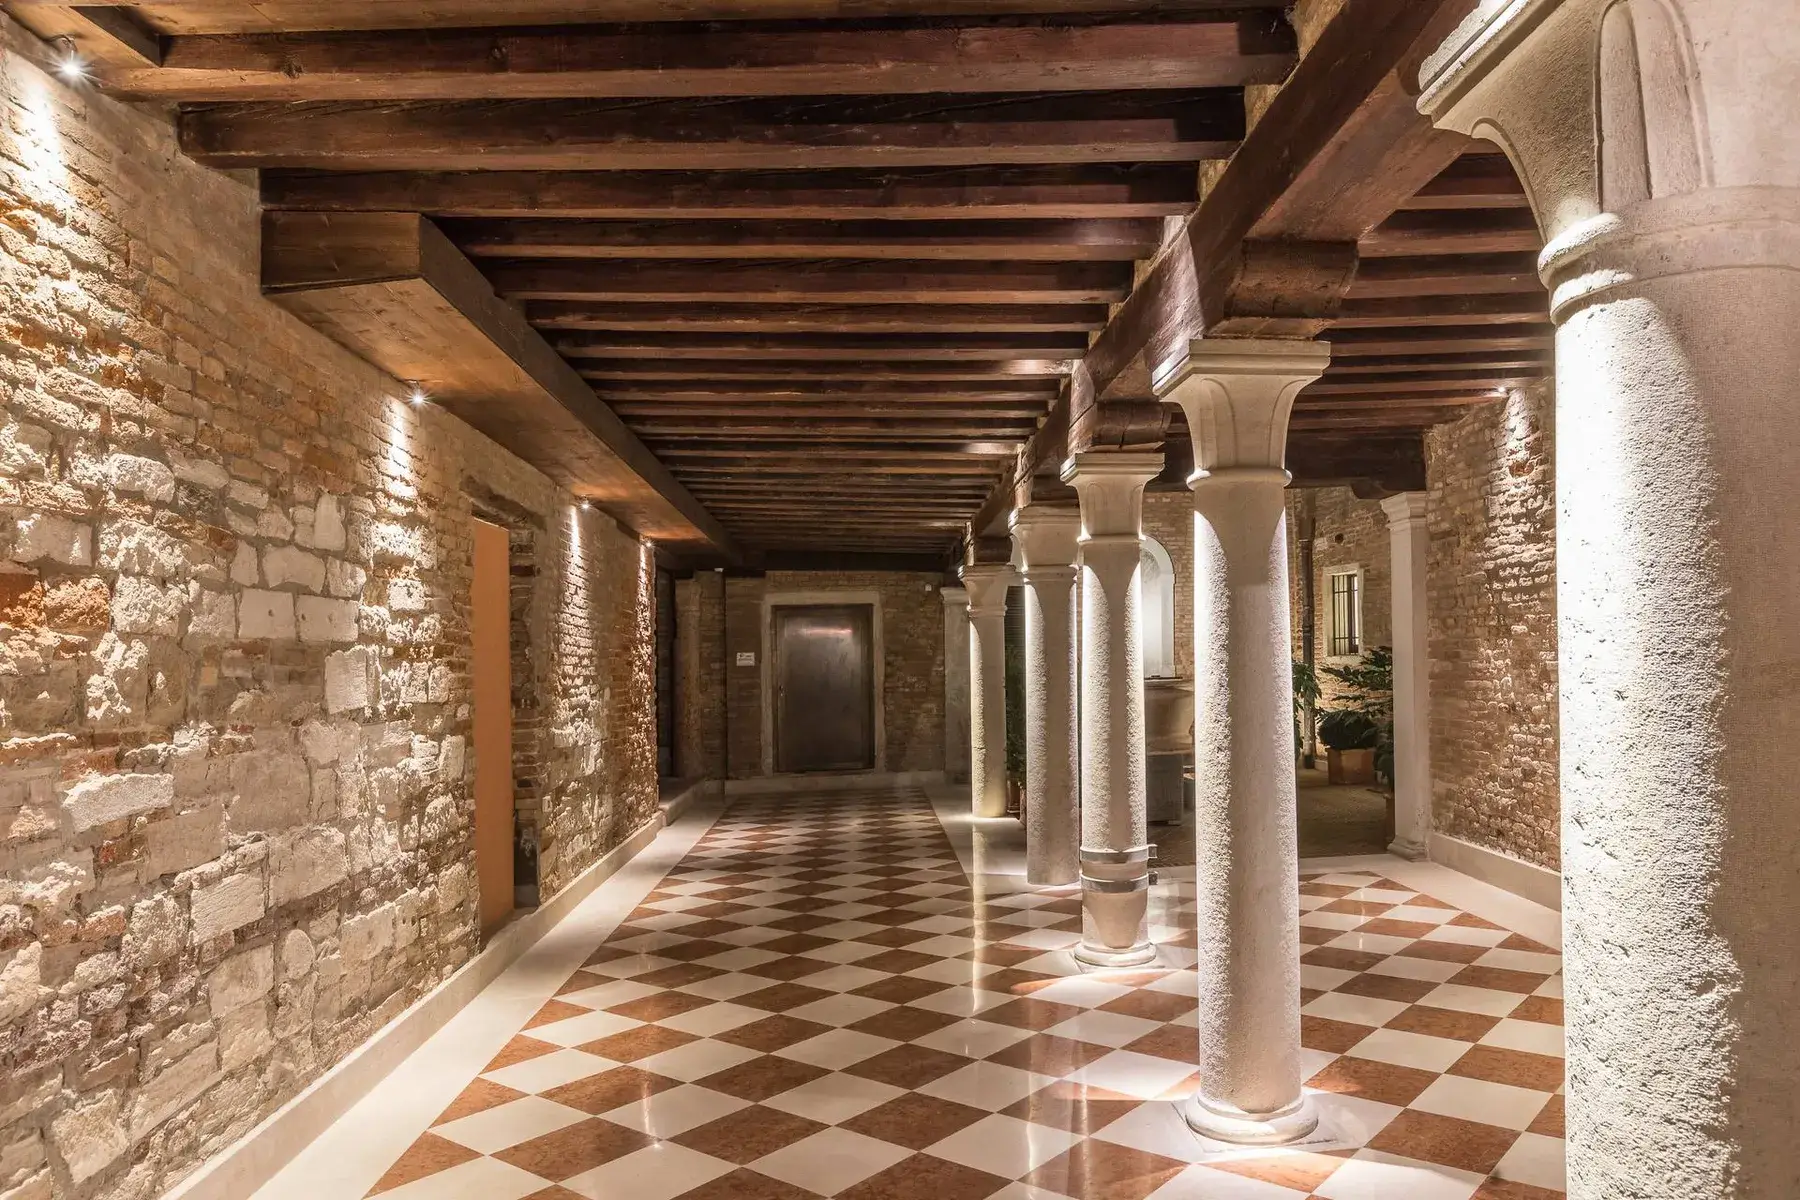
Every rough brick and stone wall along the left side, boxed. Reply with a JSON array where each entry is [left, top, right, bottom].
[[0, 32, 655, 1200]]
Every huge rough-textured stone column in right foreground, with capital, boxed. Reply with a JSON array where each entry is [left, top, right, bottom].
[[1420, 0, 1800, 1200]]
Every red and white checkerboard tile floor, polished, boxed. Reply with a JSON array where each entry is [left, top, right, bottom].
[[371, 792, 1562, 1200]]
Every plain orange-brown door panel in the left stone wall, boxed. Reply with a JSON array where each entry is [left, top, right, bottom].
[[470, 520, 513, 934]]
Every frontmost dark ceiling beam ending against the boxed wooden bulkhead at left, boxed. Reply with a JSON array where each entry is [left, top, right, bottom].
[[445, 218, 1163, 263]]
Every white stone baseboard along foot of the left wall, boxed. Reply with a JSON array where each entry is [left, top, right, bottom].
[[162, 811, 666, 1200]]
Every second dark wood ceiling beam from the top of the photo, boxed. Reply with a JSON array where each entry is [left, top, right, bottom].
[[180, 90, 1244, 172]]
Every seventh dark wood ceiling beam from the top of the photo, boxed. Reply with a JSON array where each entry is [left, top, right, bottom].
[[553, 333, 1087, 365]]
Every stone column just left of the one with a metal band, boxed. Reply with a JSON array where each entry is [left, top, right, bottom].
[[1012, 504, 1082, 887]]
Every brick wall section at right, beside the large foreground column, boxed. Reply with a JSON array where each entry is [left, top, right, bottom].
[[1426, 383, 1561, 869]]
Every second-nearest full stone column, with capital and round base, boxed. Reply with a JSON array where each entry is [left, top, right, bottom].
[[1157, 338, 1330, 1144]]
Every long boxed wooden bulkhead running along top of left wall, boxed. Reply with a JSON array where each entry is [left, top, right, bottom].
[[263, 212, 736, 558]]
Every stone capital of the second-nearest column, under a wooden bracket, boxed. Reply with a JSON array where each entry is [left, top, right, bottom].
[[1156, 338, 1332, 486]]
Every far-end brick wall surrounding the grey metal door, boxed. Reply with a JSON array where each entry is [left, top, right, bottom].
[[725, 570, 943, 779]]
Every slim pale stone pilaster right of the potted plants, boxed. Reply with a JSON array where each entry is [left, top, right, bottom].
[[1381, 491, 1431, 860]]
